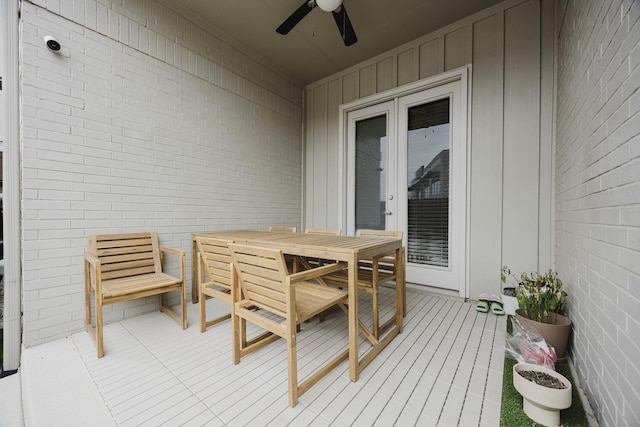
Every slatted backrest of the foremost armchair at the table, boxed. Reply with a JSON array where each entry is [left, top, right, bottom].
[[229, 243, 287, 318]]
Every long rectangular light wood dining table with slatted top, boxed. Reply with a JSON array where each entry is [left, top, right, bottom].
[[191, 230, 405, 381]]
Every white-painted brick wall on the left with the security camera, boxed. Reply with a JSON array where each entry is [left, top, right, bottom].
[[21, 0, 302, 346]]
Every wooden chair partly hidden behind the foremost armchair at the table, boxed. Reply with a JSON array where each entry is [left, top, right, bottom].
[[196, 237, 233, 332]]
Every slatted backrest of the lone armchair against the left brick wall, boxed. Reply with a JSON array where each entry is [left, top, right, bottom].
[[89, 232, 162, 280]]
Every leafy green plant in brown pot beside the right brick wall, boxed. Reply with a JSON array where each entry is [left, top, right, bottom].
[[502, 266, 571, 360]]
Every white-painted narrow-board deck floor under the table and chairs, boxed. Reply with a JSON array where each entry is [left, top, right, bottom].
[[72, 289, 506, 426]]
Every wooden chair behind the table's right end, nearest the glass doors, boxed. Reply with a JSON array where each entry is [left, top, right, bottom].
[[324, 229, 406, 338]]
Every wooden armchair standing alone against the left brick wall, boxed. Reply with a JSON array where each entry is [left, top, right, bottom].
[[84, 232, 187, 357]]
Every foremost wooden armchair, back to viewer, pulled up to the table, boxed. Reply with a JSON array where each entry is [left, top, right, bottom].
[[229, 244, 349, 407]]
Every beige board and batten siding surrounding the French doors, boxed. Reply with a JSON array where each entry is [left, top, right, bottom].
[[304, 0, 553, 298]]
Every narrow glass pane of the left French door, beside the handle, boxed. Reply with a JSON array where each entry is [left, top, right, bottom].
[[355, 115, 387, 230]]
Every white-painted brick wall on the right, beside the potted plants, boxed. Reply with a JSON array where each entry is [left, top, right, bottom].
[[556, 0, 640, 427]]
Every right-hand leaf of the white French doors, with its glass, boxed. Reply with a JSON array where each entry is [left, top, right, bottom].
[[397, 80, 466, 291]]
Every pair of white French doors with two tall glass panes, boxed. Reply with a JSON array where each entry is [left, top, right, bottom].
[[346, 80, 467, 295]]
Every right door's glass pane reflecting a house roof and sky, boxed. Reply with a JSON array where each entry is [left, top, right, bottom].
[[407, 98, 451, 267]]
